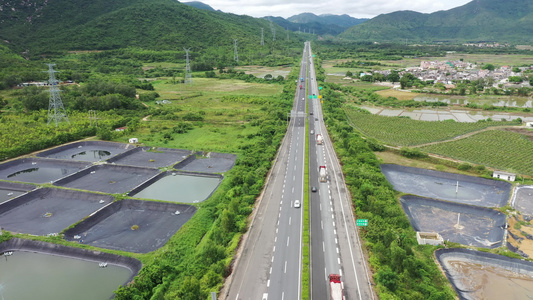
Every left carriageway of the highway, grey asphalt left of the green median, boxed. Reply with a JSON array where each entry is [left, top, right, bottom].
[[221, 42, 308, 300]]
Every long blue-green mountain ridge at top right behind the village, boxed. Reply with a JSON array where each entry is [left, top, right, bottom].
[[339, 0, 533, 43]]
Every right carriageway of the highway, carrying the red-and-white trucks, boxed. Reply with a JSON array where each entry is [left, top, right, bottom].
[[307, 47, 374, 300]]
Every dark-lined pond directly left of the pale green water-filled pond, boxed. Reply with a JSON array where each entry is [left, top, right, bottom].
[[54, 164, 159, 194]]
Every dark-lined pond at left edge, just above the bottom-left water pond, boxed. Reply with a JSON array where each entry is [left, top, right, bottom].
[[0, 188, 114, 235]]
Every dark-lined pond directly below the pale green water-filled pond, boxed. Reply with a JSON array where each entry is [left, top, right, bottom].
[[64, 199, 196, 253]]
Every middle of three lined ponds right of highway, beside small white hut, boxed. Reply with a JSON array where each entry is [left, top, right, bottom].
[[400, 196, 506, 248]]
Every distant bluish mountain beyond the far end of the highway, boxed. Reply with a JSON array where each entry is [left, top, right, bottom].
[[265, 13, 368, 35]]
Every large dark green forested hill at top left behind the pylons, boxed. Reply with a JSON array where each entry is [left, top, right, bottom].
[[0, 0, 294, 54]]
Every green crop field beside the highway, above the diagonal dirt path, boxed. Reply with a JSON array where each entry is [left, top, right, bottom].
[[344, 107, 508, 146]]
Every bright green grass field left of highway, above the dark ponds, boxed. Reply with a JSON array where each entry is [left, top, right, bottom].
[[131, 78, 283, 153]]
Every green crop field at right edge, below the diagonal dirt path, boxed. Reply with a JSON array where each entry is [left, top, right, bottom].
[[420, 130, 533, 175]]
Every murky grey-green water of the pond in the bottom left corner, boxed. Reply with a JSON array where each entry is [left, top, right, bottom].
[[0, 251, 132, 300]]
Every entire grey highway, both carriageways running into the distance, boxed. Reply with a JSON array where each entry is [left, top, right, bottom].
[[220, 42, 374, 300]]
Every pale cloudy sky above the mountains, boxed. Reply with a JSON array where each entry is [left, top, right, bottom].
[[196, 0, 475, 18]]
